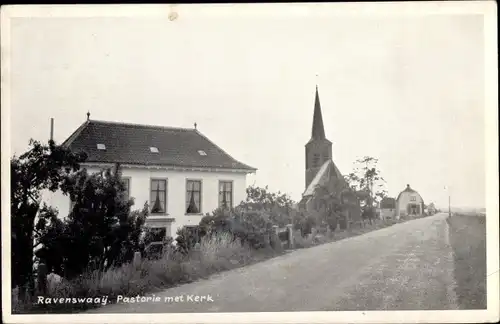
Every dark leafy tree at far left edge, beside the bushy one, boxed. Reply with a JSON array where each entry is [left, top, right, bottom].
[[10, 140, 86, 299]]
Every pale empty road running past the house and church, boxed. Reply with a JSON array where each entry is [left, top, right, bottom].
[[90, 214, 458, 313]]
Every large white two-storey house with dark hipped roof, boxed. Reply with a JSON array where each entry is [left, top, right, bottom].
[[41, 119, 256, 237]]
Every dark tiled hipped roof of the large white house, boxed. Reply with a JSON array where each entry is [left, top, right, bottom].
[[63, 120, 256, 172]]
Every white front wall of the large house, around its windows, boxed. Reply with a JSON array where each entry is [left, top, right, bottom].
[[44, 168, 246, 237]]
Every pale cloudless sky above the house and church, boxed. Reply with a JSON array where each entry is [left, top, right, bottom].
[[5, 7, 485, 207]]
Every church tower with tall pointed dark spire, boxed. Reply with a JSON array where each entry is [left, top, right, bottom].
[[306, 86, 332, 188]]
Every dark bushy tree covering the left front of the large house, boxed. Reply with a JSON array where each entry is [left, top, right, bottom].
[[41, 164, 148, 278]]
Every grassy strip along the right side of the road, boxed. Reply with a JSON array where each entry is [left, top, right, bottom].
[[448, 214, 486, 309]]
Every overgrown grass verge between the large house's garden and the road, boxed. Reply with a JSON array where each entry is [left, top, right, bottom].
[[12, 235, 280, 314]]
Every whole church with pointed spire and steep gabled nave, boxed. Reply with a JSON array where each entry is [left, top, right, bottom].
[[299, 86, 361, 229]]
